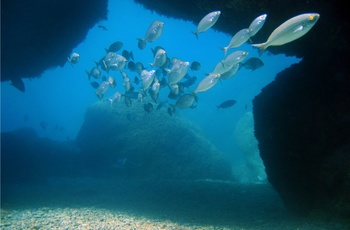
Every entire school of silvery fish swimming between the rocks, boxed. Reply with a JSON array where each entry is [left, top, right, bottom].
[[67, 11, 320, 116]]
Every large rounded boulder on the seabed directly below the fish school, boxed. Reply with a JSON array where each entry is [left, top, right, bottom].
[[76, 101, 231, 180]]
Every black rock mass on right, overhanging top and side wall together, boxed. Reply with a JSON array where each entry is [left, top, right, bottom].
[[135, 0, 350, 216]]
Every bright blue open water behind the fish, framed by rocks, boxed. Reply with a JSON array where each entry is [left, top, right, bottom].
[[1, 0, 300, 181]]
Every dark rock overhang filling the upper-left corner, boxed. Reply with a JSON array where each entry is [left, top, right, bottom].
[[1, 0, 108, 88]]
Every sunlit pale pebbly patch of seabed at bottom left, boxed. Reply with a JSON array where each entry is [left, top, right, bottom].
[[0, 207, 219, 230]]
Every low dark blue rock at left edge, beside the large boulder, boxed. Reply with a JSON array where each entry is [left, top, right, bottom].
[[1, 128, 80, 186]]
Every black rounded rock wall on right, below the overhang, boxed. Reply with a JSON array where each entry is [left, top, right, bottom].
[[253, 51, 350, 215]]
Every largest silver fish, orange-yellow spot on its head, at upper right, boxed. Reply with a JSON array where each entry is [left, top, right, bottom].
[[252, 13, 320, 55]]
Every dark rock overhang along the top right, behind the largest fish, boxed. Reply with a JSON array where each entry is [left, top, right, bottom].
[[134, 0, 350, 57]]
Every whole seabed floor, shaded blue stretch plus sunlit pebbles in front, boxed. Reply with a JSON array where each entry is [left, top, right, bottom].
[[0, 178, 350, 230]]
